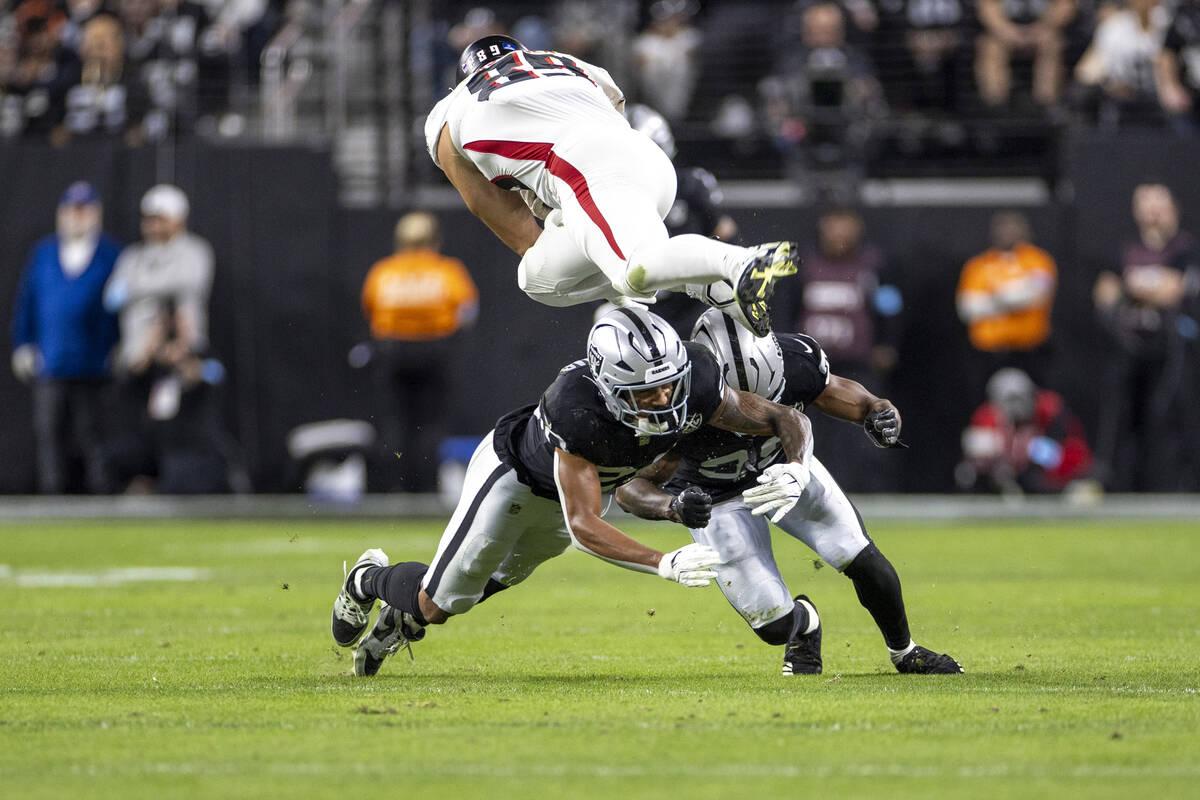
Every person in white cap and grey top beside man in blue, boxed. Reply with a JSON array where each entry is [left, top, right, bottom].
[[104, 184, 221, 491]]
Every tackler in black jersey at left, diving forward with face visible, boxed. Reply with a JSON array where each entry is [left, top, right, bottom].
[[332, 306, 816, 675]]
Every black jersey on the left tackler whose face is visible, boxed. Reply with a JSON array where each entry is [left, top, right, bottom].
[[493, 342, 725, 501]]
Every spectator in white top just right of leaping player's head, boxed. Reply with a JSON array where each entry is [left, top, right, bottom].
[[634, 0, 700, 124]]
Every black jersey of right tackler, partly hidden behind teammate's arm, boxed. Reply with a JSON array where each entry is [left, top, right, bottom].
[[666, 333, 829, 503]]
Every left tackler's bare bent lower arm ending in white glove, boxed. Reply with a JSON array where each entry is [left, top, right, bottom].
[[554, 449, 721, 587]]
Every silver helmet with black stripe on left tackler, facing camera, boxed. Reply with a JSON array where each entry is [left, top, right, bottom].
[[588, 305, 691, 435]]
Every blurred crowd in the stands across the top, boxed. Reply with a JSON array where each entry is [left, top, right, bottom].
[[0, 0, 1200, 179]]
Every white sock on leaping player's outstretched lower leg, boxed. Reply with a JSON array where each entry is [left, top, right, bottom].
[[625, 234, 750, 294]]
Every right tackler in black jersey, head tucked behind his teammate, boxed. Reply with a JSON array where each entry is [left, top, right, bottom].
[[617, 311, 962, 675]]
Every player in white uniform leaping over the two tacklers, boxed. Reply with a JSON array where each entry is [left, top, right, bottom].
[[425, 35, 797, 336]]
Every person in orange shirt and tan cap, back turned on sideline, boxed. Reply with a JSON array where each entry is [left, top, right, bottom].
[[362, 211, 479, 492]]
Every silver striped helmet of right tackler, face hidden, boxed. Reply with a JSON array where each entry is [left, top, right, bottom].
[[691, 308, 784, 401]]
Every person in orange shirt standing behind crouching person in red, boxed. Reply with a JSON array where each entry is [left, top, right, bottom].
[[955, 211, 1058, 397]]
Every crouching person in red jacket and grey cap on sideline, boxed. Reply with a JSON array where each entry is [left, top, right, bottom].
[[954, 367, 1092, 494]]
